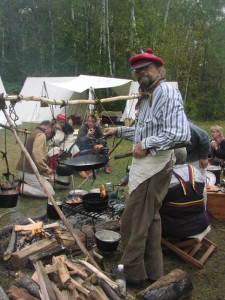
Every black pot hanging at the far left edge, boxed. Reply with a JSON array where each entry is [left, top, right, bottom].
[[0, 185, 19, 208]]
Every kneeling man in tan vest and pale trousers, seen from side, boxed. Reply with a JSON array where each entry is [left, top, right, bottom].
[[16, 121, 55, 198]]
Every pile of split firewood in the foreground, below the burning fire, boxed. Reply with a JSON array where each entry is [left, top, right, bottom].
[[3, 255, 134, 300]]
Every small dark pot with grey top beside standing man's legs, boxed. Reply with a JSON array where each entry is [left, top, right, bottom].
[[95, 230, 121, 252]]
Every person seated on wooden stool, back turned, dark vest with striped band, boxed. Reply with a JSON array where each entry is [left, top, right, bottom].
[[159, 164, 208, 239]]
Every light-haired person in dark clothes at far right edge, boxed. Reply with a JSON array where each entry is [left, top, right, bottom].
[[209, 125, 225, 167]]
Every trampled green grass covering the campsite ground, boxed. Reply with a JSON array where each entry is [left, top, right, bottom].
[[0, 121, 225, 300]]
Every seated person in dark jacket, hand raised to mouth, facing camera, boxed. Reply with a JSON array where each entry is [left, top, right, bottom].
[[77, 115, 112, 175]]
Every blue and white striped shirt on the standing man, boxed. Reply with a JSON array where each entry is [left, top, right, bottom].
[[117, 81, 190, 151]]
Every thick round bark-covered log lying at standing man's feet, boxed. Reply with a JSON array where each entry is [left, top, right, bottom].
[[136, 269, 193, 300]]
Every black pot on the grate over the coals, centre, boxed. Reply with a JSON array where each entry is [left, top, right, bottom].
[[82, 193, 109, 212]]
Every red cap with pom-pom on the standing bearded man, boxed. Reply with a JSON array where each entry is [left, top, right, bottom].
[[129, 48, 164, 69]]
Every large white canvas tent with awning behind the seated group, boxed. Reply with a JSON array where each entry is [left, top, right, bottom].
[[15, 75, 131, 123]]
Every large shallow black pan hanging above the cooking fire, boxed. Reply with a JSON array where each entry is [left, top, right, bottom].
[[63, 154, 109, 171]]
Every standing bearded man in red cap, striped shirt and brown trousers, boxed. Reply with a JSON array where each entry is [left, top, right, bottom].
[[105, 49, 190, 287]]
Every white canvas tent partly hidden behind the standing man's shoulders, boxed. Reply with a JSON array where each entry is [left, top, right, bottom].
[[121, 81, 178, 121]]
